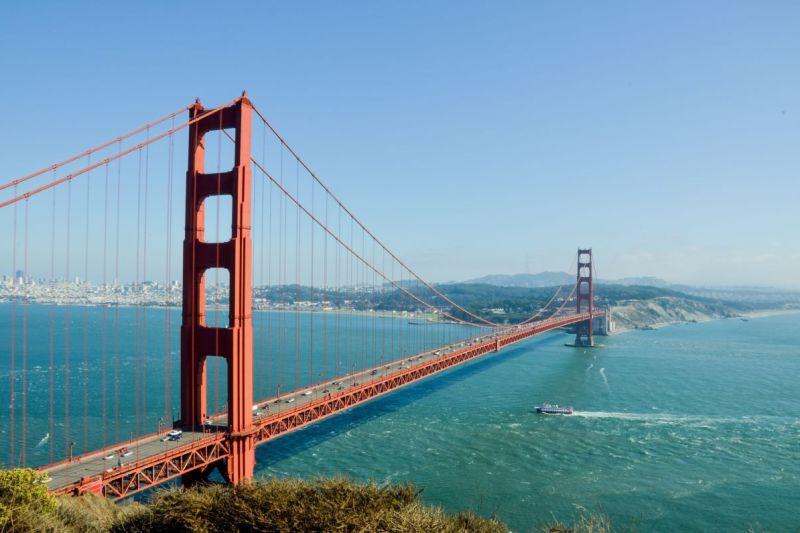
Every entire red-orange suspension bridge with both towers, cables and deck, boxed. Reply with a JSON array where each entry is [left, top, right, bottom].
[[0, 94, 605, 498]]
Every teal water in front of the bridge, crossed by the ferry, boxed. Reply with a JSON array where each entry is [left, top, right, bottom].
[[257, 315, 800, 531]]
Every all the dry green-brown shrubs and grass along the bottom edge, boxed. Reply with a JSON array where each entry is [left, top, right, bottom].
[[0, 469, 611, 533]]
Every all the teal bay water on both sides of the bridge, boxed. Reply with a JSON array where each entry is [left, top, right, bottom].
[[0, 305, 800, 531]]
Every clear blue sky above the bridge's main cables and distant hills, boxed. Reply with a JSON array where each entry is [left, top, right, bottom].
[[0, 1, 800, 287]]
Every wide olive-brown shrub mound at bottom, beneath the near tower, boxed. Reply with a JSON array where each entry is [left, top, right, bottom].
[[113, 478, 506, 533]]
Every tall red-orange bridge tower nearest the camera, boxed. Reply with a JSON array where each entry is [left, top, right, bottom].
[[178, 96, 255, 483]]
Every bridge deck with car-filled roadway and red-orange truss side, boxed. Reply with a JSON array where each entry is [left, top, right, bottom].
[[40, 310, 604, 498]]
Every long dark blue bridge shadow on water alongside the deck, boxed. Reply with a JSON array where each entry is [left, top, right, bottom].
[[256, 334, 560, 470]]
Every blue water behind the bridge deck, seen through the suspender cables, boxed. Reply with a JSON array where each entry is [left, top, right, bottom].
[[0, 304, 478, 466]]
